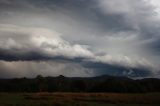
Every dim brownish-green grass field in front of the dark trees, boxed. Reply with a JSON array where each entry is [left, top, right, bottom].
[[0, 93, 160, 106]]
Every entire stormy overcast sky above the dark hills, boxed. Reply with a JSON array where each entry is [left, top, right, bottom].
[[0, 0, 160, 78]]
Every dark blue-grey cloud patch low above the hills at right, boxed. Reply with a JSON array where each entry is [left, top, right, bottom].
[[83, 62, 154, 78]]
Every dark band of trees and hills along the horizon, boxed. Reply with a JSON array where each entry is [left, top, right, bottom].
[[0, 75, 160, 93]]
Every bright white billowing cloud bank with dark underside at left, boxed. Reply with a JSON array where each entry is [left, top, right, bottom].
[[0, 25, 92, 60]]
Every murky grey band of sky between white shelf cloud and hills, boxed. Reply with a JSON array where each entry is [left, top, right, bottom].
[[0, 57, 155, 78]]
